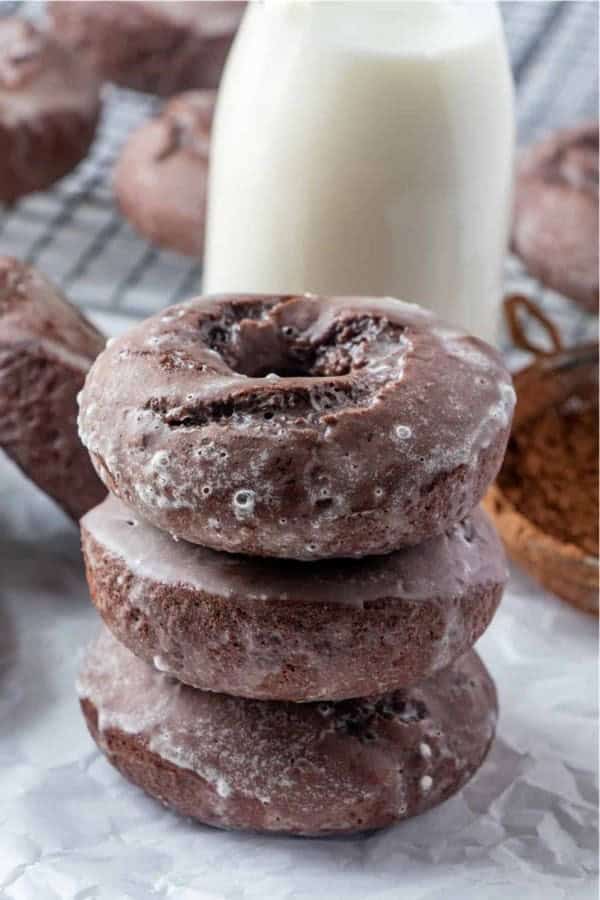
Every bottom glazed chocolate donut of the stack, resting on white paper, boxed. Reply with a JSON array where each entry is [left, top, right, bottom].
[[78, 631, 497, 835]]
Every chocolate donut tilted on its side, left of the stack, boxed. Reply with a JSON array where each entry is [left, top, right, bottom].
[[0, 256, 106, 519]]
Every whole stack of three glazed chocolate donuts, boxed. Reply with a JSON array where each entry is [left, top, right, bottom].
[[79, 296, 514, 835]]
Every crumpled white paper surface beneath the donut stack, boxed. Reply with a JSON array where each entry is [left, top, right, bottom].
[[0, 398, 598, 900]]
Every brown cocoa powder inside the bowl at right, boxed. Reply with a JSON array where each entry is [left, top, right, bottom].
[[499, 394, 598, 556]]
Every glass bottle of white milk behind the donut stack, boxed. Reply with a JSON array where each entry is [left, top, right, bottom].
[[204, 0, 514, 340]]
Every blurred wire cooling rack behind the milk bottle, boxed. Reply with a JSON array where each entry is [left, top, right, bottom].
[[0, 0, 598, 330]]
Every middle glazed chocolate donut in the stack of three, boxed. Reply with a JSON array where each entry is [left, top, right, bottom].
[[81, 497, 506, 701]]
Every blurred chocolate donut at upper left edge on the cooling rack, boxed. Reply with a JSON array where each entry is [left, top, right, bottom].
[[0, 18, 100, 203]]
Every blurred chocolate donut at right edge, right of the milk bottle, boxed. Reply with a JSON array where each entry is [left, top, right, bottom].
[[512, 122, 598, 312]]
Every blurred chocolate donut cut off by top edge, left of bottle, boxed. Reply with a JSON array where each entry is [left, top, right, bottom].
[[48, 0, 246, 97]]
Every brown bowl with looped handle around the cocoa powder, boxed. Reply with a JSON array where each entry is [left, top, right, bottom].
[[484, 297, 599, 615]]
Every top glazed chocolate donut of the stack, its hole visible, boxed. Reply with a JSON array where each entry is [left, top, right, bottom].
[[79, 296, 514, 559]]
